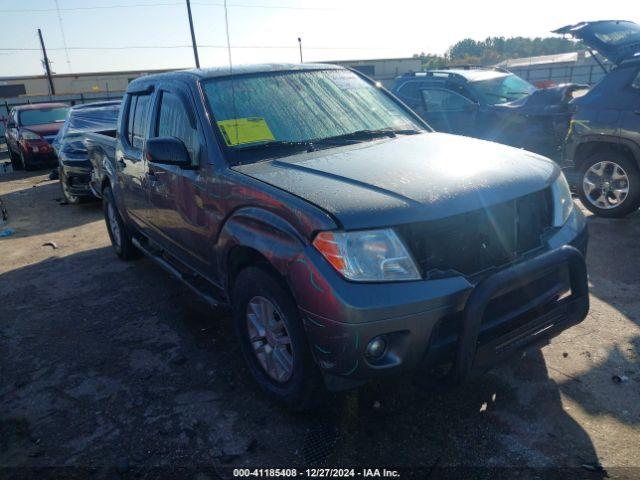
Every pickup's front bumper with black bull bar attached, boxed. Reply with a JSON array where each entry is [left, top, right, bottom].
[[290, 209, 588, 388]]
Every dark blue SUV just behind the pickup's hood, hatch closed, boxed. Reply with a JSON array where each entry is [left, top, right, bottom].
[[392, 66, 588, 160]]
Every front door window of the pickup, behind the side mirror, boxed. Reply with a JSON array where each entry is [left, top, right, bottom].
[[156, 92, 198, 162]]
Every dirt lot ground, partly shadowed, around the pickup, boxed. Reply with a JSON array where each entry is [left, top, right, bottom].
[[0, 173, 640, 478]]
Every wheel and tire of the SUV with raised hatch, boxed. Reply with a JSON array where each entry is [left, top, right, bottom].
[[576, 151, 640, 218]]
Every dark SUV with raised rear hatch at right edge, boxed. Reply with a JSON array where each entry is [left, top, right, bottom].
[[555, 21, 640, 217]]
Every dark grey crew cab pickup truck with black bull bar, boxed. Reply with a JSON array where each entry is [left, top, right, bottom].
[[99, 64, 589, 408]]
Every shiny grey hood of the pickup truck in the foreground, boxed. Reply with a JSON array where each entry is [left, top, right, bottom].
[[233, 133, 559, 229]]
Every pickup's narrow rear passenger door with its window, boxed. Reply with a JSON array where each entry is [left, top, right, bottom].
[[115, 91, 153, 230]]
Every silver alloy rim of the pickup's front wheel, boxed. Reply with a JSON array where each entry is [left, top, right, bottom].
[[246, 296, 294, 383]]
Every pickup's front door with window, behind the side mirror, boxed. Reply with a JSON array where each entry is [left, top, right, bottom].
[[147, 85, 212, 269]]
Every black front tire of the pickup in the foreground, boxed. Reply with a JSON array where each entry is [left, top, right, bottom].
[[232, 266, 326, 411]]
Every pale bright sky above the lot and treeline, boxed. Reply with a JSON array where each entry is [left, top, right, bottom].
[[0, 0, 640, 77]]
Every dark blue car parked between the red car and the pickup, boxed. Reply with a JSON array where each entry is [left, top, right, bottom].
[[53, 100, 120, 204]]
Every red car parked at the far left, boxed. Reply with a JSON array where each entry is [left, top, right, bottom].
[[5, 103, 69, 170]]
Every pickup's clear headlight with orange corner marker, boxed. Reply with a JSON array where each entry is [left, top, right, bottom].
[[313, 229, 420, 282]]
